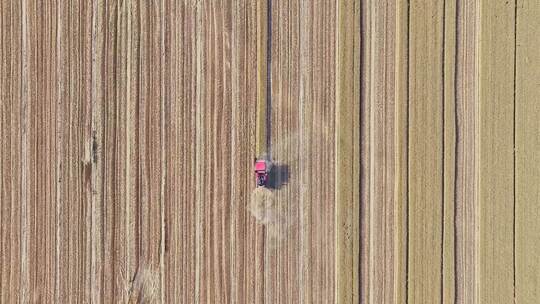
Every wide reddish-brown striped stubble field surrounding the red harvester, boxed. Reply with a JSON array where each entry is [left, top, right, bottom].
[[0, 1, 335, 303]]
